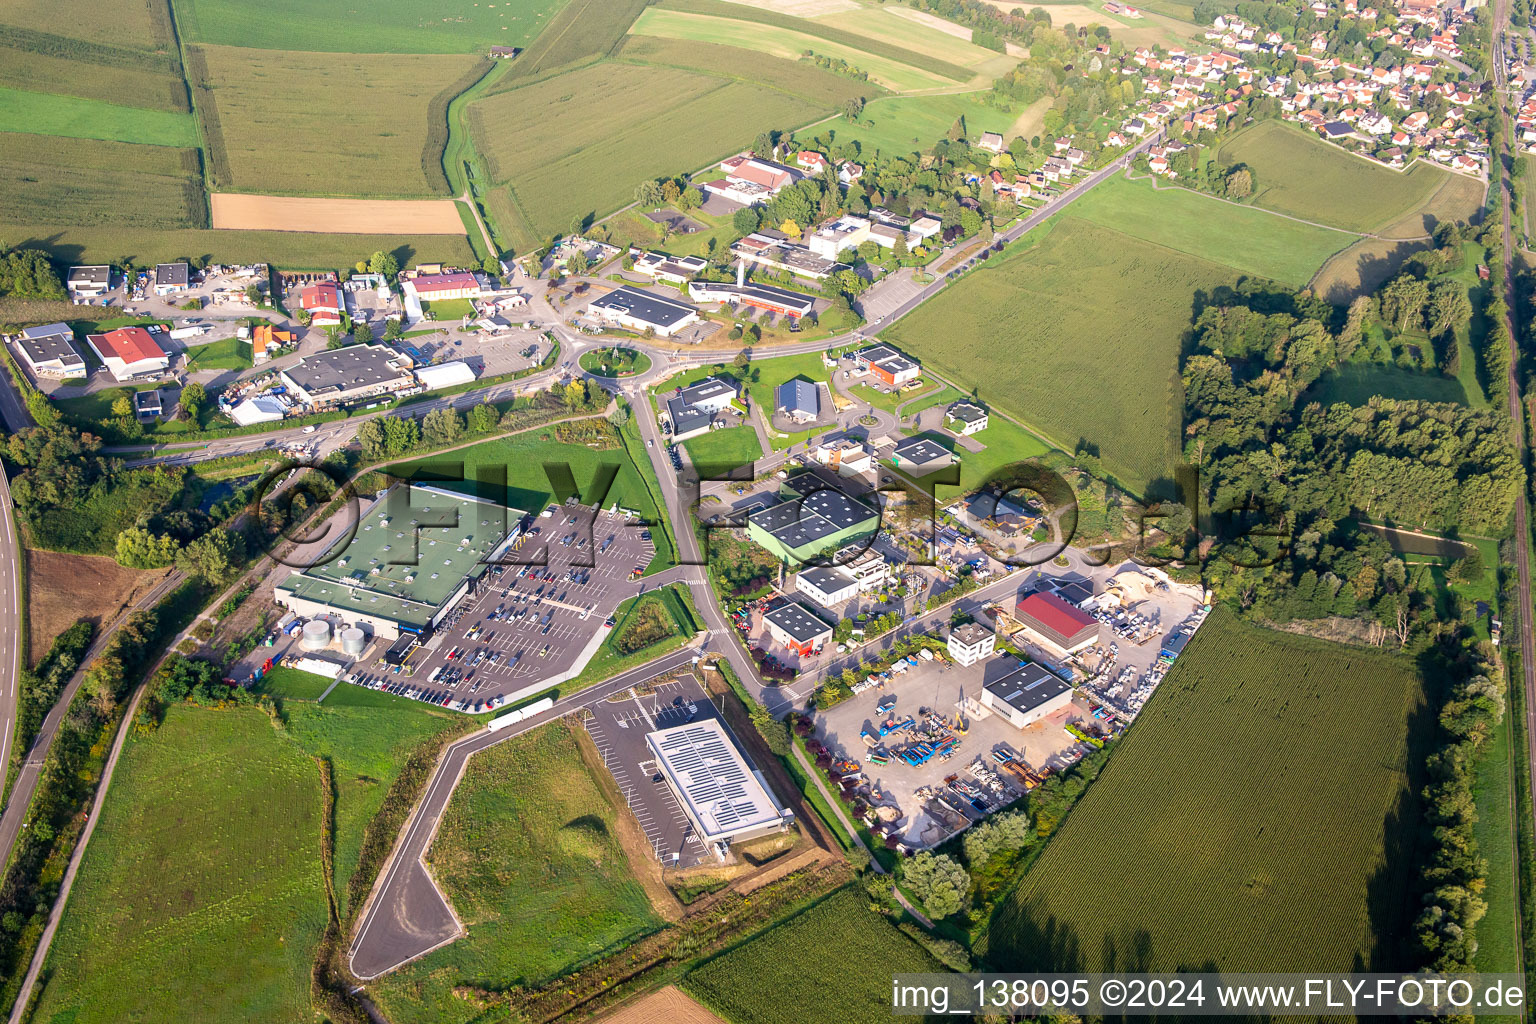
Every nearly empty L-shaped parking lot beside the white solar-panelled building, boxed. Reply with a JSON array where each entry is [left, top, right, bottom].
[[587, 674, 718, 867]]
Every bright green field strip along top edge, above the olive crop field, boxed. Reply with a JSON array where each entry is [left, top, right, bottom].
[[177, 0, 565, 54]]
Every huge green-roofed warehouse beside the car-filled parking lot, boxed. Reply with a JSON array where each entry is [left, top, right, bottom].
[[276, 484, 524, 640]]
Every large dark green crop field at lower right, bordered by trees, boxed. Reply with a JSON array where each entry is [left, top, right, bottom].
[[986, 609, 1436, 972]]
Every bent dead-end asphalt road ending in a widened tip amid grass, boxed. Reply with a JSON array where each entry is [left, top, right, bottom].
[[347, 648, 696, 981]]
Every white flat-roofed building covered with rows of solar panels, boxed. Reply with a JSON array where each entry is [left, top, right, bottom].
[[645, 718, 794, 849]]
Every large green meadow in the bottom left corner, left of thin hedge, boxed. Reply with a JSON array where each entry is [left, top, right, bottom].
[[28, 706, 326, 1024]]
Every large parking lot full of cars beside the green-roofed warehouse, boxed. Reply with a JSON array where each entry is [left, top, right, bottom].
[[355, 505, 656, 712]]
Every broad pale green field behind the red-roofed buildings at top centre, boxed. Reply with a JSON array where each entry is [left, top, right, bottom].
[[468, 63, 825, 247]]
